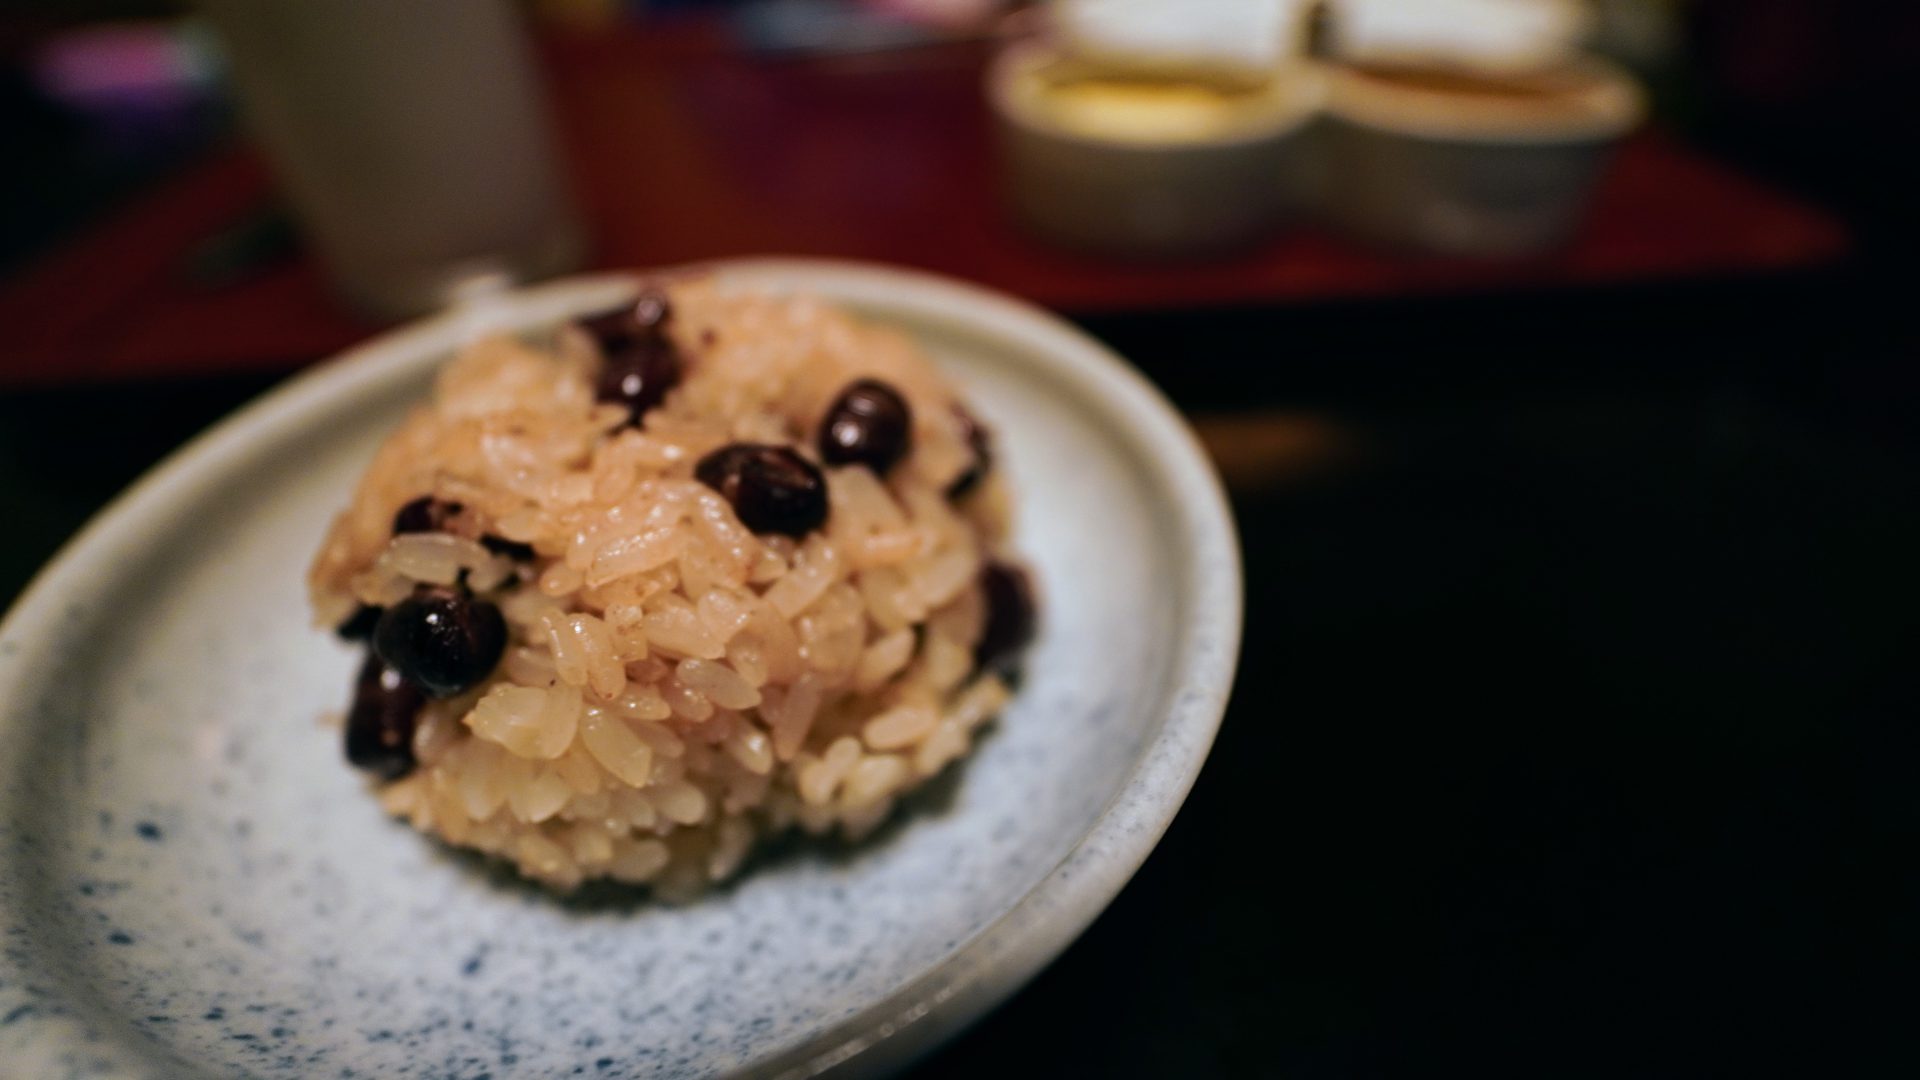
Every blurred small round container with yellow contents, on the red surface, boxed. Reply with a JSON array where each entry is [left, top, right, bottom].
[[987, 40, 1319, 256]]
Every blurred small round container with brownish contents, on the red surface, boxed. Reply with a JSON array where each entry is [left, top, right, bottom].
[[1317, 56, 1645, 258]]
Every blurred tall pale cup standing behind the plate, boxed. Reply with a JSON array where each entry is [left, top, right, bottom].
[[198, 0, 582, 317]]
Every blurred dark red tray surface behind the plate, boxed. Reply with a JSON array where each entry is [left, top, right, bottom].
[[0, 25, 1847, 384]]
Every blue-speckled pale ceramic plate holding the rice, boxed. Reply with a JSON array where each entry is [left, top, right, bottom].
[[0, 261, 1240, 1080]]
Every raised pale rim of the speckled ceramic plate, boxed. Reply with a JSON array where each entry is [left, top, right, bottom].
[[0, 256, 1244, 1080]]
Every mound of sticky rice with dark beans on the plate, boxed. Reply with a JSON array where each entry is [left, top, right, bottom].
[[309, 281, 1033, 896]]
